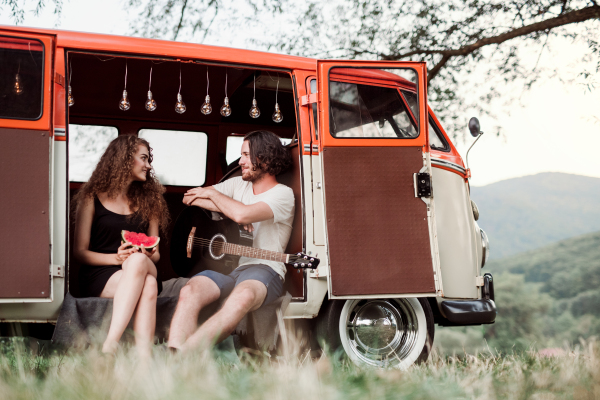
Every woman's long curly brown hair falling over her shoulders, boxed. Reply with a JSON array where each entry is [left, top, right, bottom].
[[73, 135, 170, 233]]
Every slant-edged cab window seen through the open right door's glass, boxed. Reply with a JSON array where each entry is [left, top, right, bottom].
[[329, 81, 419, 138]]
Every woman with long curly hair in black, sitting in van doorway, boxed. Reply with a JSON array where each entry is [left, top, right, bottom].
[[73, 135, 169, 356]]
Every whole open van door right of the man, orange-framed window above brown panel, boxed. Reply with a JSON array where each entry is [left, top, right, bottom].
[[317, 61, 442, 298]]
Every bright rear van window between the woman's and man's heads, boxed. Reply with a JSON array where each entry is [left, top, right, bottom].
[[138, 129, 208, 186]]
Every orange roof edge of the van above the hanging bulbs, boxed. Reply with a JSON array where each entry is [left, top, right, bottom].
[[0, 25, 317, 71]]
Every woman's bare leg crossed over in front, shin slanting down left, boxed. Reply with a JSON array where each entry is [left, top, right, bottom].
[[100, 253, 156, 353]]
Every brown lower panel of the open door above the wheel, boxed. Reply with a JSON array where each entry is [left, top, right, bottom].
[[323, 147, 435, 296]]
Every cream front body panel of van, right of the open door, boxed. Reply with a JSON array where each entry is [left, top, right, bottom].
[[432, 168, 478, 299]]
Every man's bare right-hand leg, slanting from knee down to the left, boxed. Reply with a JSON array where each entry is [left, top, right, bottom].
[[180, 280, 267, 351]]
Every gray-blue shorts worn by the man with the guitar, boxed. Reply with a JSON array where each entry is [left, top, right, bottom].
[[194, 264, 284, 305]]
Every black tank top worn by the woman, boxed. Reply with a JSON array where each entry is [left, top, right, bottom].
[[89, 197, 148, 254]]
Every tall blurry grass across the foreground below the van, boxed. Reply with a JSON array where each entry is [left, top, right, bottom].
[[0, 339, 600, 400]]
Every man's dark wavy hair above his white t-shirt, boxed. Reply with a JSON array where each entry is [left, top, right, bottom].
[[244, 131, 292, 176]]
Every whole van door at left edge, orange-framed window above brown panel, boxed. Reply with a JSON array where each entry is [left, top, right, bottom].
[[0, 29, 55, 303]]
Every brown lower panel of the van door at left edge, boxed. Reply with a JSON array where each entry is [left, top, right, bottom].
[[0, 128, 50, 298]]
